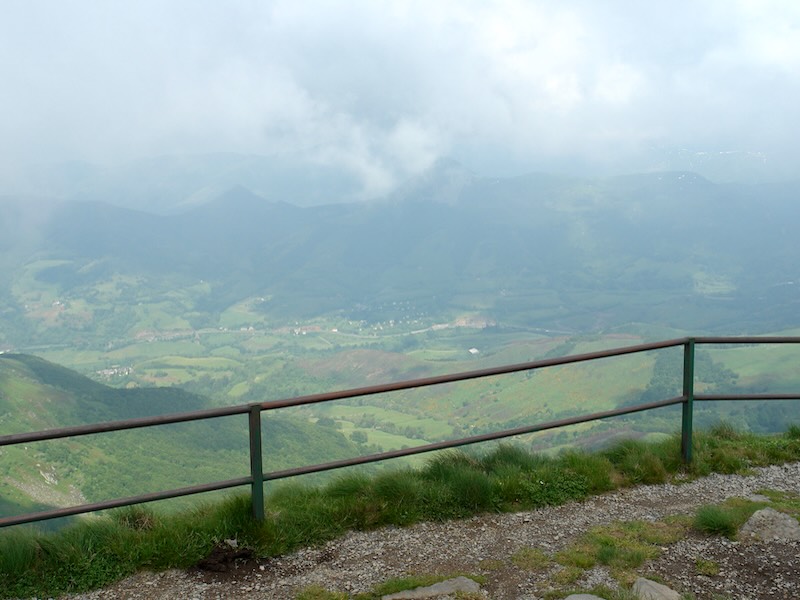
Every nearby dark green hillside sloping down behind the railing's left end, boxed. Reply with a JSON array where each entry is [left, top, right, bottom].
[[0, 354, 357, 514]]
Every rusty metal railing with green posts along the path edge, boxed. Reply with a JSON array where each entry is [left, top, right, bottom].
[[0, 337, 800, 527]]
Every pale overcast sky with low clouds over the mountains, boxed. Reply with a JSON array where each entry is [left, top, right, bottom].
[[0, 0, 800, 192]]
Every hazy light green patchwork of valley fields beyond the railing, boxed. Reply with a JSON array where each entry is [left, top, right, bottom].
[[17, 310, 800, 460]]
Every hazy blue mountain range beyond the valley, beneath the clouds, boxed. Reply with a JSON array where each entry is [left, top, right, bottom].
[[0, 162, 800, 345]]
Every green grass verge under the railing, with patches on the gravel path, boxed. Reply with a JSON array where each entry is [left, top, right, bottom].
[[0, 427, 800, 598]]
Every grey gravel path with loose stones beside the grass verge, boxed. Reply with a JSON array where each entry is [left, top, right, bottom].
[[65, 463, 800, 600]]
